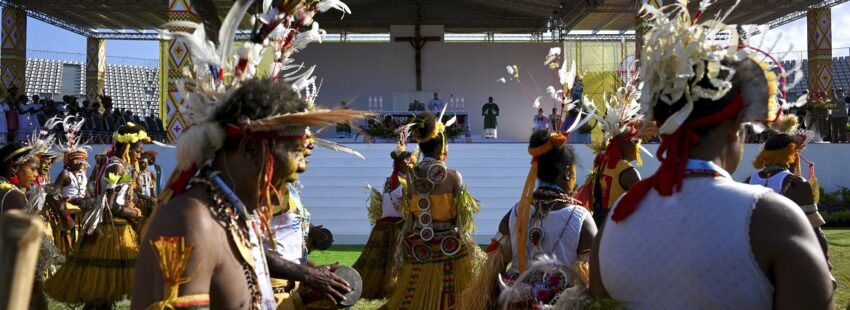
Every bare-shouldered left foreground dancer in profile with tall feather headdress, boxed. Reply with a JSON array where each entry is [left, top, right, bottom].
[[132, 1, 368, 309]]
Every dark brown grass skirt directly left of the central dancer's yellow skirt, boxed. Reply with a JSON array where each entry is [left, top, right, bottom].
[[352, 217, 403, 299]]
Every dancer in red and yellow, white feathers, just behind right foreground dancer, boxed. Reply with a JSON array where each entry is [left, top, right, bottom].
[[586, 78, 657, 228]]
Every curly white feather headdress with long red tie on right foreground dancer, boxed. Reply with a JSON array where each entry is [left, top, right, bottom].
[[612, 0, 800, 222]]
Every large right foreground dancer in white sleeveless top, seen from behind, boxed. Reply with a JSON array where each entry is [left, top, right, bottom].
[[590, 1, 832, 309]]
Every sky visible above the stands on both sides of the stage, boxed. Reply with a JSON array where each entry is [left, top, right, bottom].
[[19, 3, 850, 61]]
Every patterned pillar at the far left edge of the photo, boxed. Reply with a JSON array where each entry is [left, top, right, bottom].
[[0, 6, 27, 98]]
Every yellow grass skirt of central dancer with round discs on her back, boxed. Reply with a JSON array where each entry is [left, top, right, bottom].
[[383, 232, 473, 310]]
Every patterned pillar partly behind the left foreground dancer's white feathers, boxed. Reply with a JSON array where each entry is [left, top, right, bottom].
[[159, 0, 201, 141]]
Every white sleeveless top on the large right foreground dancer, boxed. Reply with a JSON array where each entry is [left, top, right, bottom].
[[599, 171, 773, 309]]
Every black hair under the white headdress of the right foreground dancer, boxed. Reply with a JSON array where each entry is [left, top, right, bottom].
[[652, 58, 767, 136]]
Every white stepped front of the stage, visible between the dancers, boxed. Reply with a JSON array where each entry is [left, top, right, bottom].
[[63, 143, 850, 244]]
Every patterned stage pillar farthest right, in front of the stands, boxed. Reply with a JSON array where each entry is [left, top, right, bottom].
[[806, 8, 834, 98]]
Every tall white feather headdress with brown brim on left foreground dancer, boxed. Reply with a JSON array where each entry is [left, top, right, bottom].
[[157, 0, 371, 246]]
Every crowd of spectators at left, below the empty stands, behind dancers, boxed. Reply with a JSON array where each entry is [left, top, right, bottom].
[[0, 87, 165, 143]]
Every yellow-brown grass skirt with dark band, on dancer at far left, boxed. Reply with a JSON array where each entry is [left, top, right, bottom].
[[45, 220, 139, 304]]
